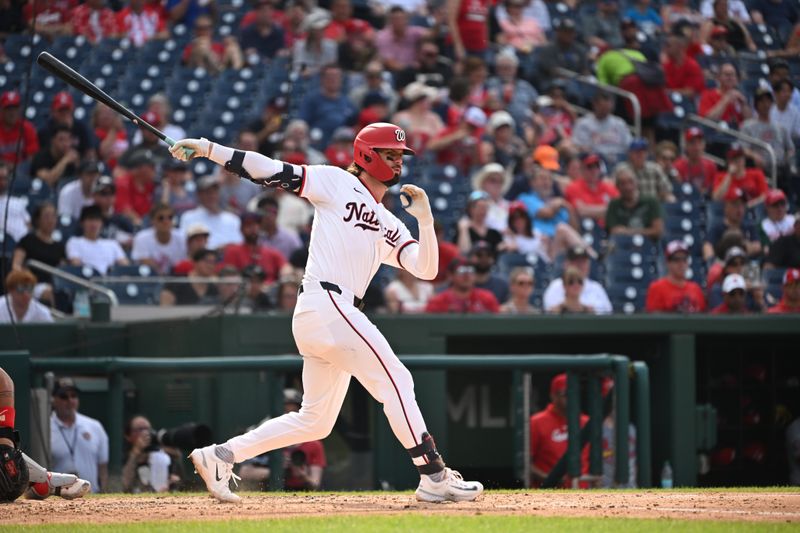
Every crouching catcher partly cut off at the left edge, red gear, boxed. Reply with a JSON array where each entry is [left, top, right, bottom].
[[0, 368, 91, 502]]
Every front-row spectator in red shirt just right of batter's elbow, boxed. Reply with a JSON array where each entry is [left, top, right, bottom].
[[425, 258, 500, 314]]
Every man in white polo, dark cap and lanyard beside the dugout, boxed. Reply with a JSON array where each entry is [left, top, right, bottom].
[[50, 378, 108, 492]]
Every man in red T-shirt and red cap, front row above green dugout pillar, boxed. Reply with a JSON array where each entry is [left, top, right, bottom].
[[645, 241, 706, 313]]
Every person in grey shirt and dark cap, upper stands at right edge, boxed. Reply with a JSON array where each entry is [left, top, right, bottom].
[[741, 88, 795, 183]]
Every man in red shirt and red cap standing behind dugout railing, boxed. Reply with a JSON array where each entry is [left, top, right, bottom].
[[530, 374, 589, 487]]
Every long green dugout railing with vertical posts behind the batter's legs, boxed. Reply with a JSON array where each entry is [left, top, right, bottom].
[[0, 351, 652, 490]]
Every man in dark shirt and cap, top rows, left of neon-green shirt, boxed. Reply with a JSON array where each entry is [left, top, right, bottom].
[[536, 16, 589, 86]]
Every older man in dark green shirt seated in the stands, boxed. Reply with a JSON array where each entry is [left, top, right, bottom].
[[606, 165, 664, 241]]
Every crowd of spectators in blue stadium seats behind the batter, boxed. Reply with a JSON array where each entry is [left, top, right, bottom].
[[0, 0, 800, 321]]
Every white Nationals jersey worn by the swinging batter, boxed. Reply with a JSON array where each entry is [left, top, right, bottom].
[[298, 165, 417, 298]]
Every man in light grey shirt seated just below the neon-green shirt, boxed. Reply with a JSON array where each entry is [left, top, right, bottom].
[[572, 91, 632, 163]]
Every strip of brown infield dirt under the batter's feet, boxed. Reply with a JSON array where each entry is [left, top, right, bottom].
[[2, 490, 800, 525]]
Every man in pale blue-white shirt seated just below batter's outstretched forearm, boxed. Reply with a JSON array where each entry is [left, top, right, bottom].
[[180, 175, 242, 250]]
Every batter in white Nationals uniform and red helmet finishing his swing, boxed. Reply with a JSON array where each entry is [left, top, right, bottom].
[[171, 123, 483, 502]]
